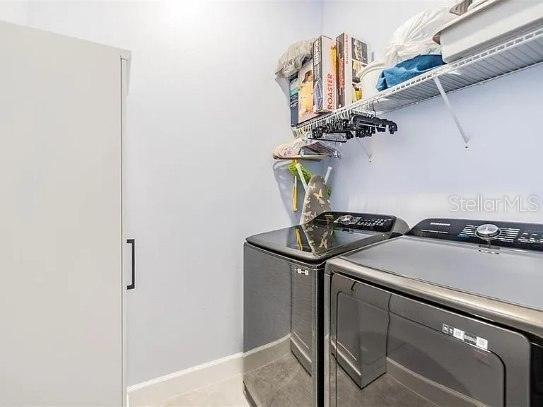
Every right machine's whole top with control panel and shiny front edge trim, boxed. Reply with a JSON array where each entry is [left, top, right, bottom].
[[326, 219, 543, 340]]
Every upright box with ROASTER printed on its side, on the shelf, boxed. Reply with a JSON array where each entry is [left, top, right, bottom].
[[313, 36, 337, 113]]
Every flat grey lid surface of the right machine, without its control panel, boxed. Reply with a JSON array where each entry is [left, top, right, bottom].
[[343, 236, 543, 310]]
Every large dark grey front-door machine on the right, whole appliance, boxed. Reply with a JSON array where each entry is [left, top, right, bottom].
[[325, 219, 543, 407]]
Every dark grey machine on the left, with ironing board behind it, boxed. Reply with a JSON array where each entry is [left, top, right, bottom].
[[243, 212, 408, 407]]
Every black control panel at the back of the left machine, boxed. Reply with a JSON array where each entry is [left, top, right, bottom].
[[315, 212, 396, 232]]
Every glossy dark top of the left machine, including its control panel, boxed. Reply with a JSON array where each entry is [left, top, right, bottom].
[[247, 212, 407, 263]]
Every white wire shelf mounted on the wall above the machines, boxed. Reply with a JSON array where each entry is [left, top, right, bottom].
[[293, 28, 543, 137]]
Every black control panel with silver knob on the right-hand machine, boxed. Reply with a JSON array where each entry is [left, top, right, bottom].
[[407, 218, 543, 251]]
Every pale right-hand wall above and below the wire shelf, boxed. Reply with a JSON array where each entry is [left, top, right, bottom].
[[323, 1, 543, 225]]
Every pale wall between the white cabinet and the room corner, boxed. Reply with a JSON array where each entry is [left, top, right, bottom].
[[20, 1, 320, 384]]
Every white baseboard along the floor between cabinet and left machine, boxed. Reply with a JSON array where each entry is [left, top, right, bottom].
[[127, 353, 243, 407]]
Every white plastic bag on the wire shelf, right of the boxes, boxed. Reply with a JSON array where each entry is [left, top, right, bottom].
[[385, 7, 457, 67]]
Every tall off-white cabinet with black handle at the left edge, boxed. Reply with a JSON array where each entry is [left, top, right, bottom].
[[0, 23, 130, 406]]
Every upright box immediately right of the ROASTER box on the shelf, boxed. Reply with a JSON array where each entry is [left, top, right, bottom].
[[336, 33, 368, 107]]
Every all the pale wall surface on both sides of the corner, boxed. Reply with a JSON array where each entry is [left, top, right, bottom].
[[4, 0, 543, 384]]
